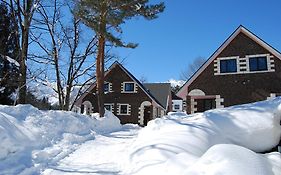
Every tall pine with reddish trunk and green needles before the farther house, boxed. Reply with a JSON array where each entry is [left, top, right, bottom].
[[76, 0, 165, 117]]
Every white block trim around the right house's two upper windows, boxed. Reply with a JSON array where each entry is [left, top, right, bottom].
[[214, 54, 275, 75]]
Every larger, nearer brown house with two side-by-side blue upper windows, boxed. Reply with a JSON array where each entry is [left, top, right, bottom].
[[177, 26, 281, 113]]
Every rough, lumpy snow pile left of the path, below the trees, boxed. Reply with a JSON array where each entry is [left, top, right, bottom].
[[0, 105, 121, 174]]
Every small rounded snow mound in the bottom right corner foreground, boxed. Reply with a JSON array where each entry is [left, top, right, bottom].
[[184, 144, 281, 175]]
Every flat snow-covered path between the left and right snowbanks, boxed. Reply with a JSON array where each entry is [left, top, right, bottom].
[[43, 125, 139, 175]]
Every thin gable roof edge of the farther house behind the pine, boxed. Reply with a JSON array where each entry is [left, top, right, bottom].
[[76, 61, 166, 110]]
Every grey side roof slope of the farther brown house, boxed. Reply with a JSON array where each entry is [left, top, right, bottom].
[[143, 83, 171, 110]]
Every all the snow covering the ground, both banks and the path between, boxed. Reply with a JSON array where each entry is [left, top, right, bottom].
[[0, 98, 281, 175]]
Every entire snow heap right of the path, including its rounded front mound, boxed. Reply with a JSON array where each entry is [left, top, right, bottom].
[[125, 98, 281, 175]]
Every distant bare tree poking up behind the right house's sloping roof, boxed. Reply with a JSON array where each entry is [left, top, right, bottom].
[[180, 57, 206, 80]]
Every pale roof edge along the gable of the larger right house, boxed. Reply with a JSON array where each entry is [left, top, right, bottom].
[[177, 25, 281, 96]]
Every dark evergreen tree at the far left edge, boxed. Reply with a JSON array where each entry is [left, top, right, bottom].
[[0, 3, 19, 104]]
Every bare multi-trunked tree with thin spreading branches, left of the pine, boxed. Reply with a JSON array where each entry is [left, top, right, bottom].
[[31, 0, 97, 110]]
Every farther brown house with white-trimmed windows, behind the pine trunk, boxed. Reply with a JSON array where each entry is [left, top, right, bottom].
[[74, 62, 171, 125]]
